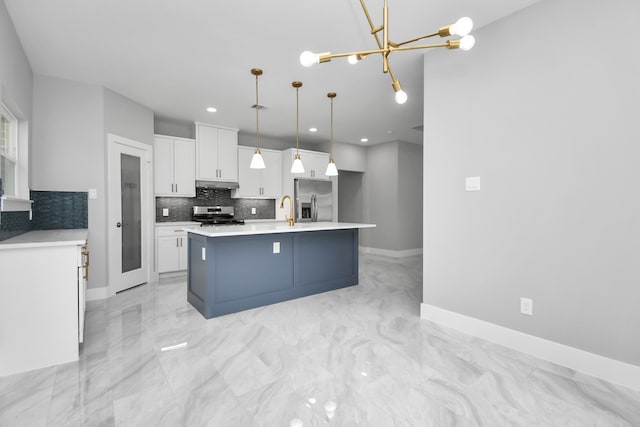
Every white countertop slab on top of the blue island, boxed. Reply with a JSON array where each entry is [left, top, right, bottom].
[[185, 221, 376, 237]]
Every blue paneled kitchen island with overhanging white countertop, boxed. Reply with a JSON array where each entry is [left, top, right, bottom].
[[187, 222, 375, 319]]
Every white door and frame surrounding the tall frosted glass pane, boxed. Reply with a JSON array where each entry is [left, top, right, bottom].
[[106, 133, 154, 296]]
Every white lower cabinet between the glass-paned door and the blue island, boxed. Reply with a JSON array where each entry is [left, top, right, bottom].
[[156, 225, 189, 273]]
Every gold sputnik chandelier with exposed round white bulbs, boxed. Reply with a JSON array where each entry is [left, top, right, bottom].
[[300, 0, 476, 104]]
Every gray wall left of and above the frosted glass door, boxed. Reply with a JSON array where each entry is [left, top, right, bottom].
[[31, 75, 153, 288]]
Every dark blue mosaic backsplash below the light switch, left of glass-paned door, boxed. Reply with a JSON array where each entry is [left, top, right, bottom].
[[31, 191, 89, 230]]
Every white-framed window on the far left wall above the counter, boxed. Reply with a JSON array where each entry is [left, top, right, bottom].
[[0, 104, 18, 196]]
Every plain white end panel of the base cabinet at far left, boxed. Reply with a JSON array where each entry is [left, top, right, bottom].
[[0, 245, 79, 377]]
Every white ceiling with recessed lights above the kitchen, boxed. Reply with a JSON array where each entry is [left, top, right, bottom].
[[4, 0, 538, 144]]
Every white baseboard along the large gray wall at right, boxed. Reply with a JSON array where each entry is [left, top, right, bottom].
[[420, 303, 640, 390]]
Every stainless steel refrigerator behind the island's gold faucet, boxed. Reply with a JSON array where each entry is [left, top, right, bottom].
[[294, 178, 333, 222]]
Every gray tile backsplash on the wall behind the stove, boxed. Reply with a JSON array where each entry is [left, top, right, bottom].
[[156, 188, 276, 222]]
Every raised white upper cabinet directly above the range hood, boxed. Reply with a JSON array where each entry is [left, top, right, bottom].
[[196, 123, 238, 182]]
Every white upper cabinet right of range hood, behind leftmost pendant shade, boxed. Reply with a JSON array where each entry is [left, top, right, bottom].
[[233, 147, 282, 199]]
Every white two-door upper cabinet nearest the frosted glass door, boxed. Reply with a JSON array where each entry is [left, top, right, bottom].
[[153, 135, 196, 197]]
